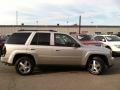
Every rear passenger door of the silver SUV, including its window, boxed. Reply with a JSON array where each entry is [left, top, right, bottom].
[[29, 33, 52, 64]]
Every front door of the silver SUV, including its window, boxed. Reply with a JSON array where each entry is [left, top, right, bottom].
[[52, 33, 82, 65]]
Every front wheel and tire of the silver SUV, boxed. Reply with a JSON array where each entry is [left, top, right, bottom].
[[87, 57, 105, 75]]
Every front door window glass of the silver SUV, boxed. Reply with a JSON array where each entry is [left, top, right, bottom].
[[54, 34, 76, 47]]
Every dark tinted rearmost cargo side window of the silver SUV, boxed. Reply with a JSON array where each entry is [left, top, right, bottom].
[[6, 33, 30, 44]]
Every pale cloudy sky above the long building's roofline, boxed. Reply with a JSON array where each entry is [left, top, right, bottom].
[[0, 0, 120, 25]]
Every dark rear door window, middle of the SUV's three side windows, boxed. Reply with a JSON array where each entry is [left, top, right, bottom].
[[31, 33, 50, 45]]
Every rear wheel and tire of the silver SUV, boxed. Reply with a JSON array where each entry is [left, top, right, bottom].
[[15, 57, 34, 75]]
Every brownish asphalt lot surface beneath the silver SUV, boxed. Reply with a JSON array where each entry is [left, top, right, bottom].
[[0, 58, 120, 90]]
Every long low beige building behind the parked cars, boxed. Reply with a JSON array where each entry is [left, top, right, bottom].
[[0, 25, 120, 35]]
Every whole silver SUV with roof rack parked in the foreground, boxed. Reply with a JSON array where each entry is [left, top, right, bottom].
[[1, 30, 112, 75]]
